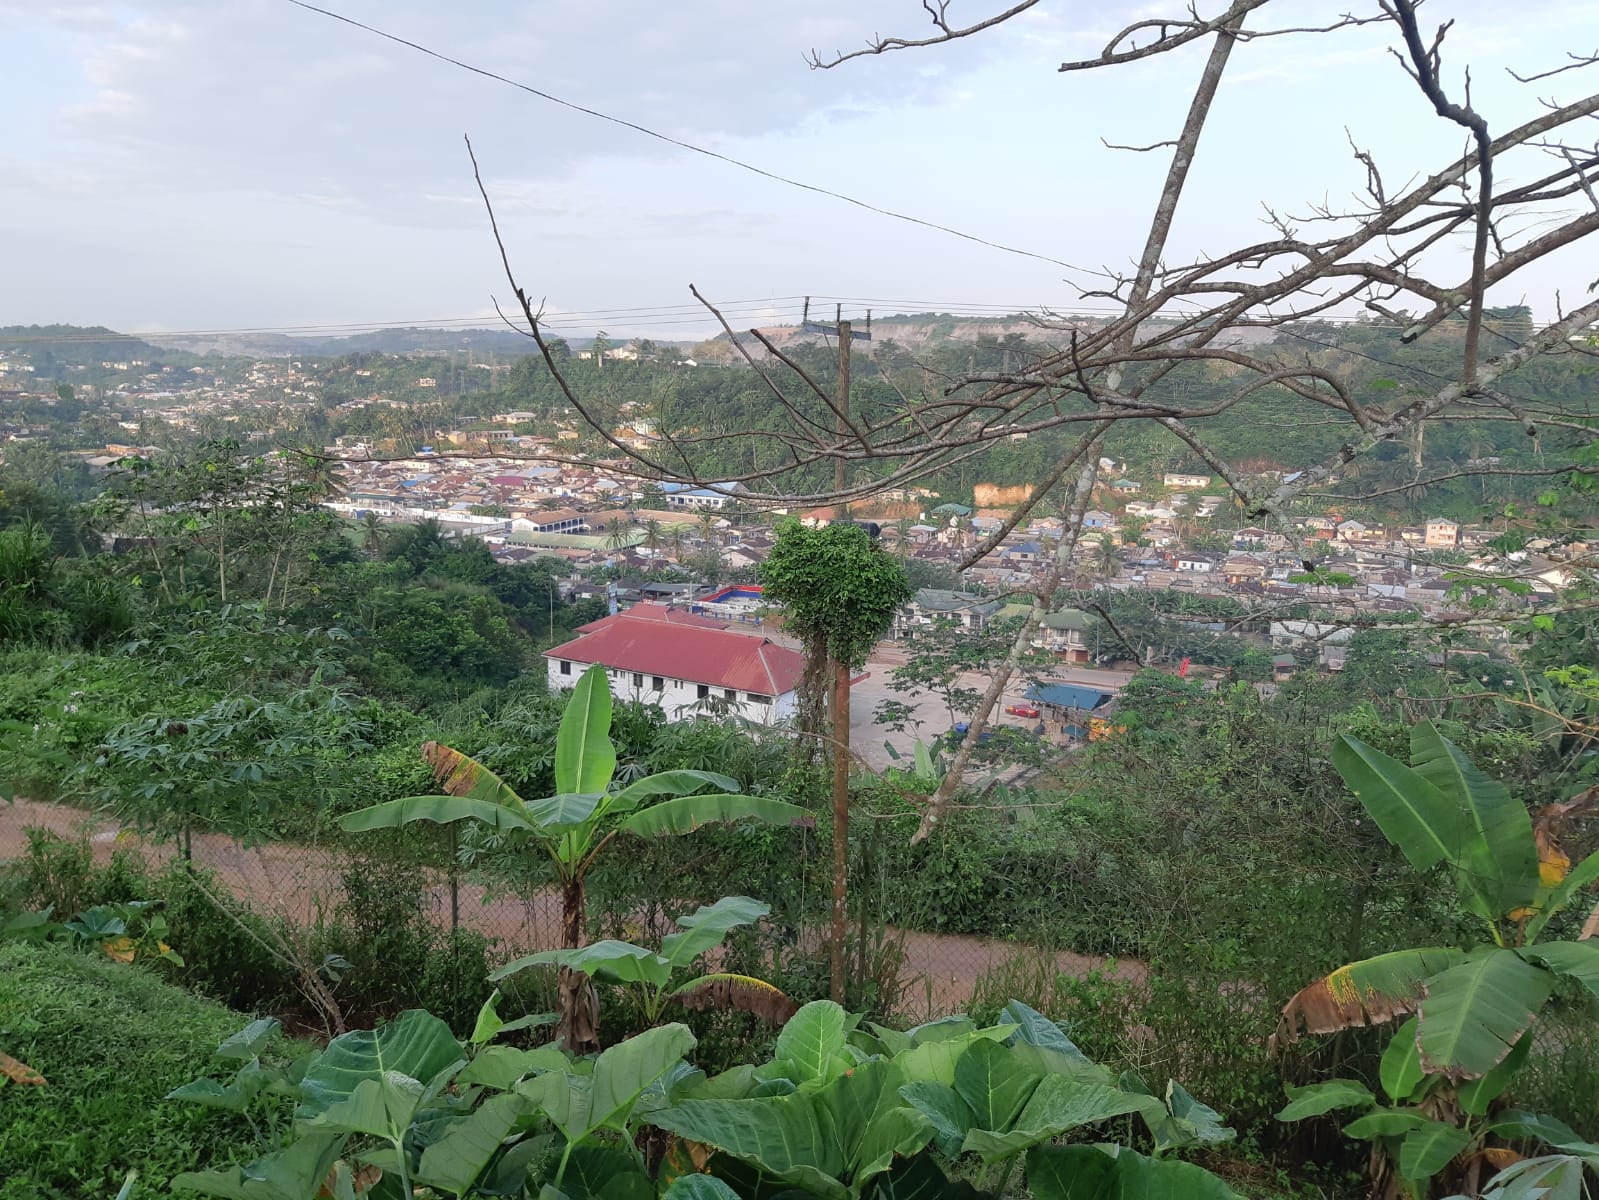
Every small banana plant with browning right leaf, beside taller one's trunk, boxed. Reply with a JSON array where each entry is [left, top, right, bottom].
[[489, 896, 798, 1024]]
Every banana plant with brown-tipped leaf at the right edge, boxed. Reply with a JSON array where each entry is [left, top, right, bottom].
[[1274, 722, 1599, 1195]]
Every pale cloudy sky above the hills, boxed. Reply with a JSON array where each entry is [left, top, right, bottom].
[[0, 0, 1596, 339]]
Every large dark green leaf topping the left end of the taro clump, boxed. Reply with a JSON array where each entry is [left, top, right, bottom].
[[294, 1008, 467, 1122]]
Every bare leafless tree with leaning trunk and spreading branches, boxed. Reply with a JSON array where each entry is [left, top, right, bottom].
[[473, 0, 1599, 838]]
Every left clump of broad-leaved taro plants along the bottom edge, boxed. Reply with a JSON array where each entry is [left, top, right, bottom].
[[169, 1010, 705, 1200]]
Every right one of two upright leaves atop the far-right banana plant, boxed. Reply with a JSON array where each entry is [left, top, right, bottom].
[[1410, 722, 1538, 922]]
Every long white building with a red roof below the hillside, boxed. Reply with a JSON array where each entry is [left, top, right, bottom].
[[544, 605, 804, 725]]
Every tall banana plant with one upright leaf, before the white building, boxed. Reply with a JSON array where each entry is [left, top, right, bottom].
[[339, 664, 807, 1053]]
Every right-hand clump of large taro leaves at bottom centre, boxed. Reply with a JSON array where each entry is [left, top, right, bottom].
[[649, 1000, 1234, 1200]]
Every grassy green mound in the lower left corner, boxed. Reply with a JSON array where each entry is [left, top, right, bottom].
[[0, 944, 270, 1200]]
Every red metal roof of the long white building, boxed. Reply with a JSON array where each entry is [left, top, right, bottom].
[[544, 608, 804, 696]]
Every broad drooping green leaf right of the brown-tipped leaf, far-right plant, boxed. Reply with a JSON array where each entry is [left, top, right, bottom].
[[1417, 949, 1554, 1078]]
